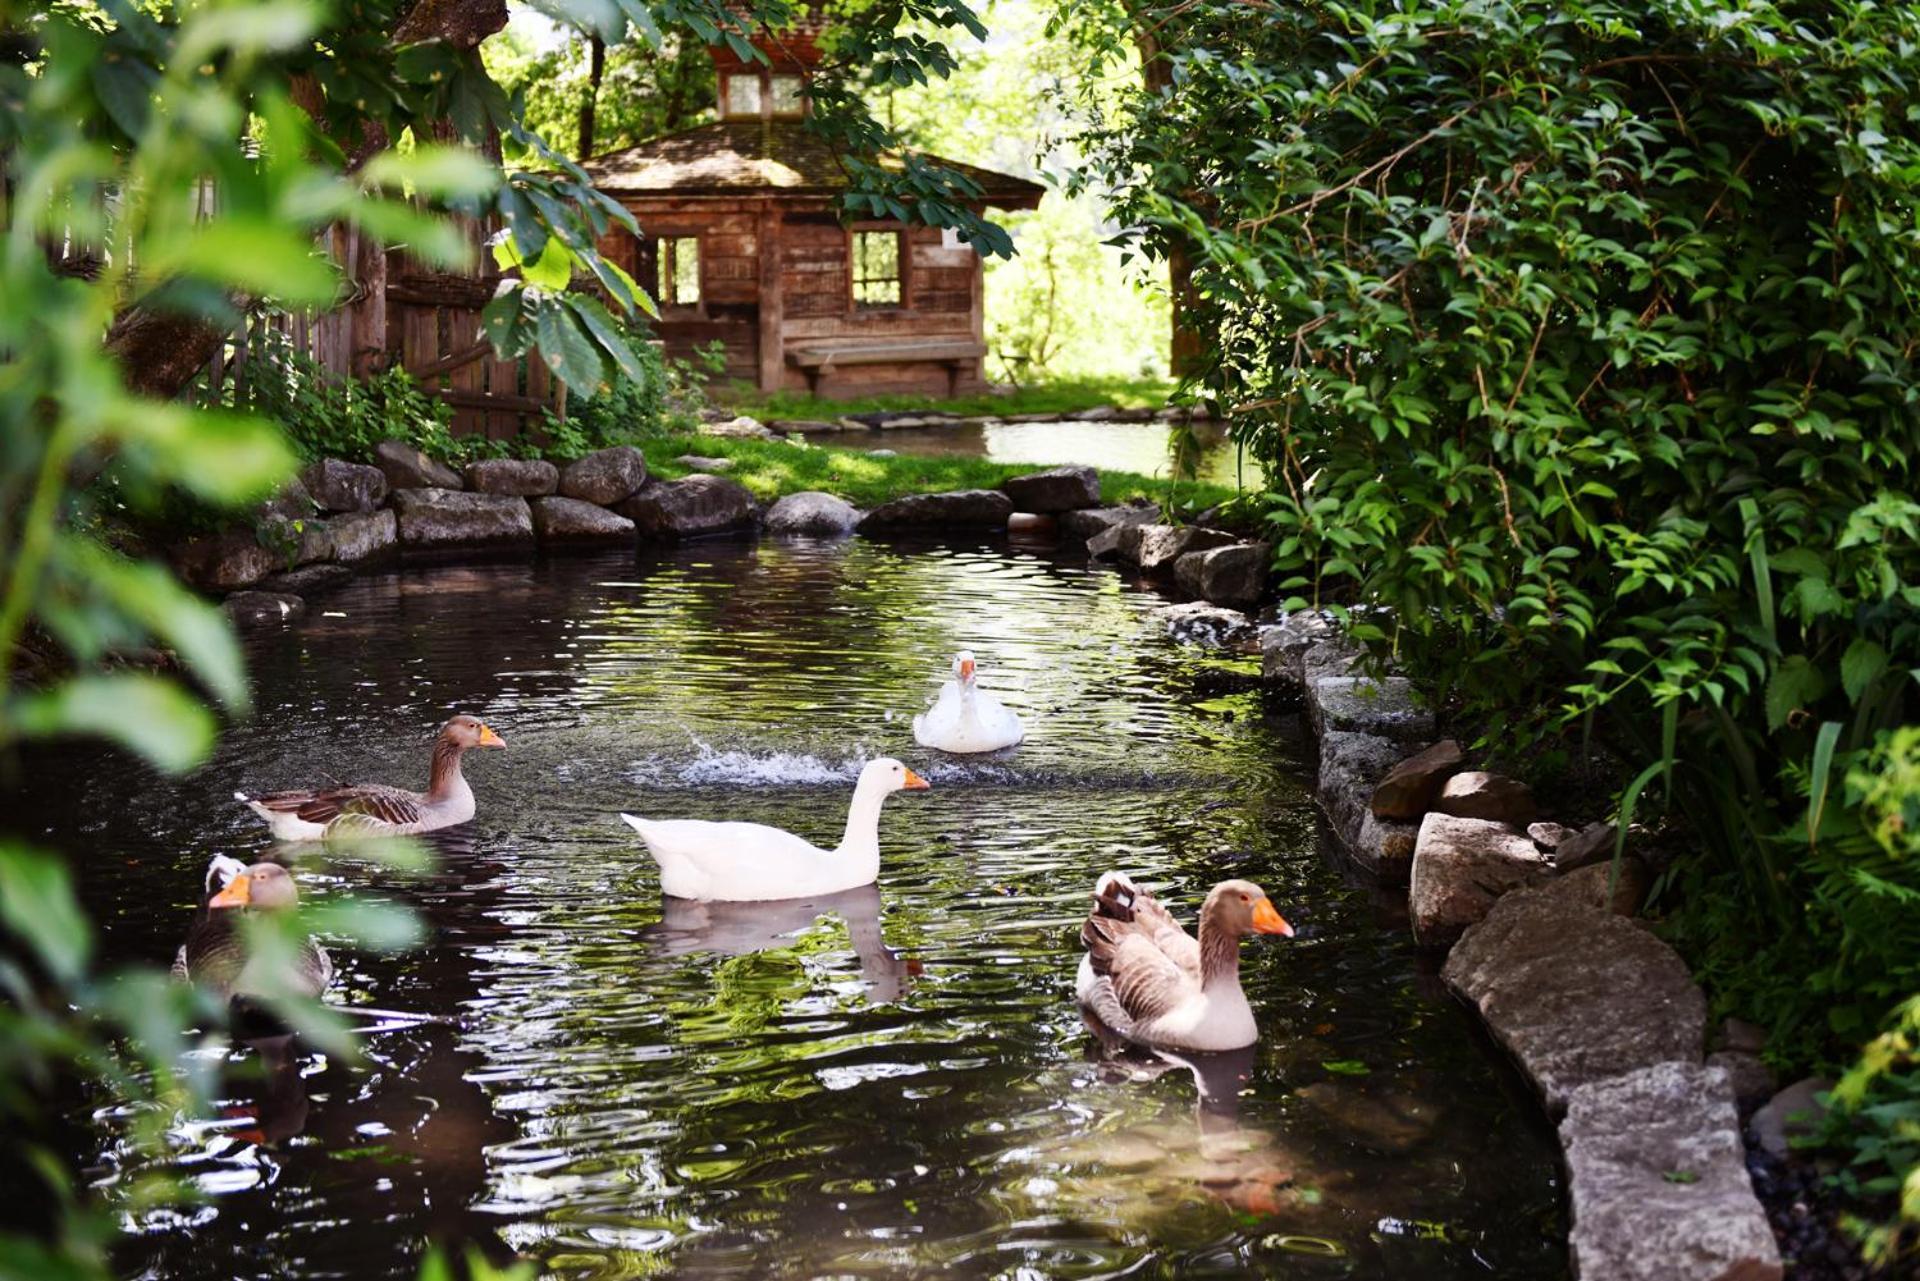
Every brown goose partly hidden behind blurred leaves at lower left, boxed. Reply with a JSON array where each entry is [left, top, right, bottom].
[[173, 855, 334, 999]]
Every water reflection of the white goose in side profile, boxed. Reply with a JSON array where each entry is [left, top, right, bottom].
[[643, 885, 912, 1003]]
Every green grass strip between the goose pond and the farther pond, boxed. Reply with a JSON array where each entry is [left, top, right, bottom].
[[639, 436, 1233, 509]]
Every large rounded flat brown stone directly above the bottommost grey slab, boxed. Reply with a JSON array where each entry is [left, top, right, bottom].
[[1443, 875, 1707, 1116]]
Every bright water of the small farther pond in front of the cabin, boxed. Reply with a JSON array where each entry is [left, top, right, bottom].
[[867, 419, 1261, 490]]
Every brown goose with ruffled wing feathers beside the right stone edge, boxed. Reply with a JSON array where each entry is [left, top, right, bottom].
[[1075, 872, 1294, 1051]]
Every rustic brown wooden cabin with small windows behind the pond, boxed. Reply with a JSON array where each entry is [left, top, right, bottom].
[[588, 29, 1044, 398]]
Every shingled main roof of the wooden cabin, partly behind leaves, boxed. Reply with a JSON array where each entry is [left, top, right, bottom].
[[586, 119, 1046, 209]]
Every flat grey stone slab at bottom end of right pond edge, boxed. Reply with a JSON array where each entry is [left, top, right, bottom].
[[1559, 1062, 1782, 1281]]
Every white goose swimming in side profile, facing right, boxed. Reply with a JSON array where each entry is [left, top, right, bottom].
[[620, 757, 927, 903]]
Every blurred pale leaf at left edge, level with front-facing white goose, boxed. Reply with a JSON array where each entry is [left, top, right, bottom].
[[12, 672, 215, 774]]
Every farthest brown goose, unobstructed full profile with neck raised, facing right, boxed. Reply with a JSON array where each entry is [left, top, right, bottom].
[[234, 716, 507, 841]]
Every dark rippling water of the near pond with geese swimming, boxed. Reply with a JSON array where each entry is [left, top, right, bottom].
[[13, 540, 1567, 1281]]
